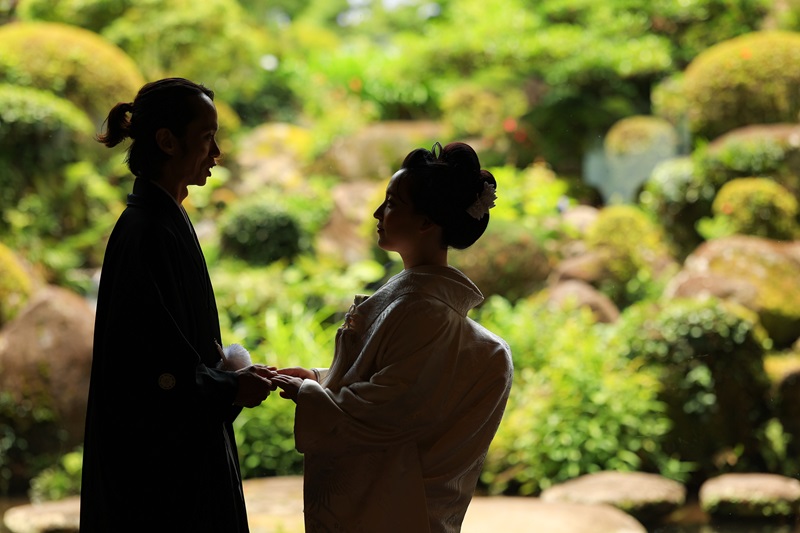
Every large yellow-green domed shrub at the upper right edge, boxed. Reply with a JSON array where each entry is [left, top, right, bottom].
[[684, 31, 800, 139]]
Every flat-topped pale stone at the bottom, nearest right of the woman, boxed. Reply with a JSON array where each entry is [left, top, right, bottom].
[[541, 471, 686, 523]]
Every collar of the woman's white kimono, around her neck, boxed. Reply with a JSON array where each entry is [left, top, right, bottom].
[[357, 266, 483, 326]]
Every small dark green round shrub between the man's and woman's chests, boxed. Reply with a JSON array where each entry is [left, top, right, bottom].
[[220, 197, 304, 265]]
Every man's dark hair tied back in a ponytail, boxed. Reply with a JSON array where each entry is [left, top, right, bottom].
[[97, 78, 214, 179]]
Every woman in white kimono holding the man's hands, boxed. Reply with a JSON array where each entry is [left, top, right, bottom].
[[273, 143, 512, 533]]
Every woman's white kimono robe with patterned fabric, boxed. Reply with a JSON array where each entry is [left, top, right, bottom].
[[295, 266, 513, 533]]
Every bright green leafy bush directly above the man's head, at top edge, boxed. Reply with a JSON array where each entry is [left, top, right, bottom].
[[108, 0, 294, 125]]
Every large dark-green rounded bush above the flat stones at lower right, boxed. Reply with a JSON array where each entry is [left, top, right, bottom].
[[615, 299, 771, 481]]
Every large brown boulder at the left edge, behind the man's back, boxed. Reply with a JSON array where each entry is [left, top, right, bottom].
[[0, 286, 94, 486]]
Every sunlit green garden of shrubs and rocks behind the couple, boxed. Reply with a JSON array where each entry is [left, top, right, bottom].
[[0, 0, 800, 512]]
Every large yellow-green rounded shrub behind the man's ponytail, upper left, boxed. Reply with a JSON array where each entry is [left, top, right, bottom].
[[0, 22, 144, 128]]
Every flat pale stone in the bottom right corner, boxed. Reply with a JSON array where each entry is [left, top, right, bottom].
[[699, 473, 800, 519]]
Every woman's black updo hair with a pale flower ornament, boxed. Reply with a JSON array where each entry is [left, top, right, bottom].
[[401, 142, 497, 250]]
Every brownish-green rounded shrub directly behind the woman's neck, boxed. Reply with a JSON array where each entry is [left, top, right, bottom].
[[450, 220, 552, 301]]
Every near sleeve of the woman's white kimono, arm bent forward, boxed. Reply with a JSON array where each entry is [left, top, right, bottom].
[[295, 299, 463, 453]]
